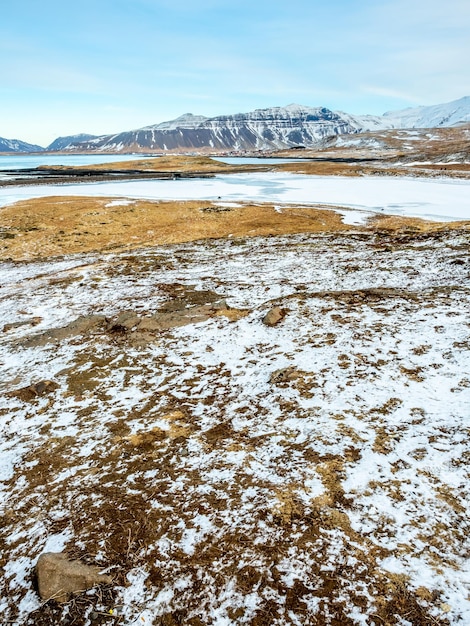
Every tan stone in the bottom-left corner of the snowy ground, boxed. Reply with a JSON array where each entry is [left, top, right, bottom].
[[36, 552, 112, 602]]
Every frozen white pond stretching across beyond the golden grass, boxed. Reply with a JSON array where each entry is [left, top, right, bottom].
[[0, 172, 470, 221]]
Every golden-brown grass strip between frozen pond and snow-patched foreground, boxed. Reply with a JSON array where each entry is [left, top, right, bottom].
[[0, 197, 470, 260]]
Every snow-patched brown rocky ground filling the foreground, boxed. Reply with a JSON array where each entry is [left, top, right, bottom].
[[0, 217, 470, 626]]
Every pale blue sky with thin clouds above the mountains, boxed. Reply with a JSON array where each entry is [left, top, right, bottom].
[[0, 0, 470, 146]]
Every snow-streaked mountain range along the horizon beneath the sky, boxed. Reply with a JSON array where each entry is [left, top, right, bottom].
[[0, 96, 470, 153]]
